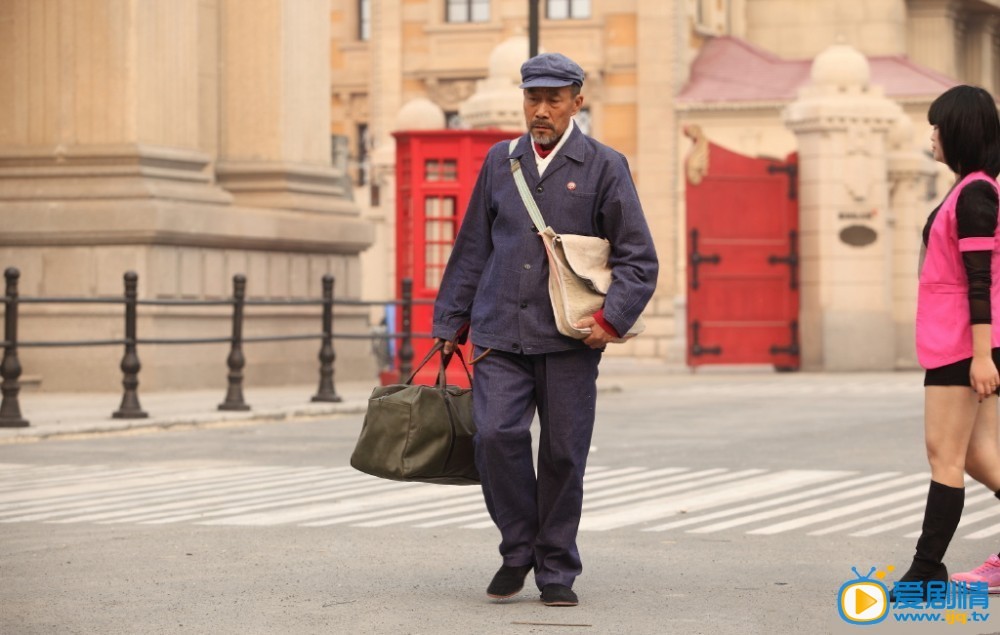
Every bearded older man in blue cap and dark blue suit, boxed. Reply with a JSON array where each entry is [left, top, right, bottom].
[[433, 53, 658, 606]]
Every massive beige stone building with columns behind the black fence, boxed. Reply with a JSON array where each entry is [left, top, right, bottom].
[[0, 0, 374, 390]]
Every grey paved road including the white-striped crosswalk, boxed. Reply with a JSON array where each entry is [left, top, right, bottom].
[[0, 367, 1000, 634]]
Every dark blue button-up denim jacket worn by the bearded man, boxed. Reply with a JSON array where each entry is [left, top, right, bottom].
[[433, 126, 659, 354]]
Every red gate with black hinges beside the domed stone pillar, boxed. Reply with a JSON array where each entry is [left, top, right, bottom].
[[685, 127, 799, 370]]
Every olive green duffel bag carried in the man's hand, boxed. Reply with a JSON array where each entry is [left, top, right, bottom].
[[351, 342, 479, 485]]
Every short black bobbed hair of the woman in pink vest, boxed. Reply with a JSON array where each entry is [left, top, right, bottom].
[[927, 86, 1000, 178]]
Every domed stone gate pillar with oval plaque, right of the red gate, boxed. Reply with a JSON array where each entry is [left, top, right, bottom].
[[784, 44, 903, 371]]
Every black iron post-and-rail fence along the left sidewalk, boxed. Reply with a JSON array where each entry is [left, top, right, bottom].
[[0, 267, 431, 428]]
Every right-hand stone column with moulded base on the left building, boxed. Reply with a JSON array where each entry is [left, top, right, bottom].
[[216, 0, 357, 216]]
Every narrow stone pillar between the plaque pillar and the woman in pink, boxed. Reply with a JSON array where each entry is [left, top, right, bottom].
[[888, 117, 937, 369]]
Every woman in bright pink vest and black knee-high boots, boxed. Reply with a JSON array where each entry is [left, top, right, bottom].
[[893, 86, 1000, 598]]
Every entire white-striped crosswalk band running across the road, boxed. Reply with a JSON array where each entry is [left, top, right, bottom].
[[0, 461, 1000, 540]]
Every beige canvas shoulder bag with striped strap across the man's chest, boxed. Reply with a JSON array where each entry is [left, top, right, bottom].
[[508, 139, 646, 343]]
